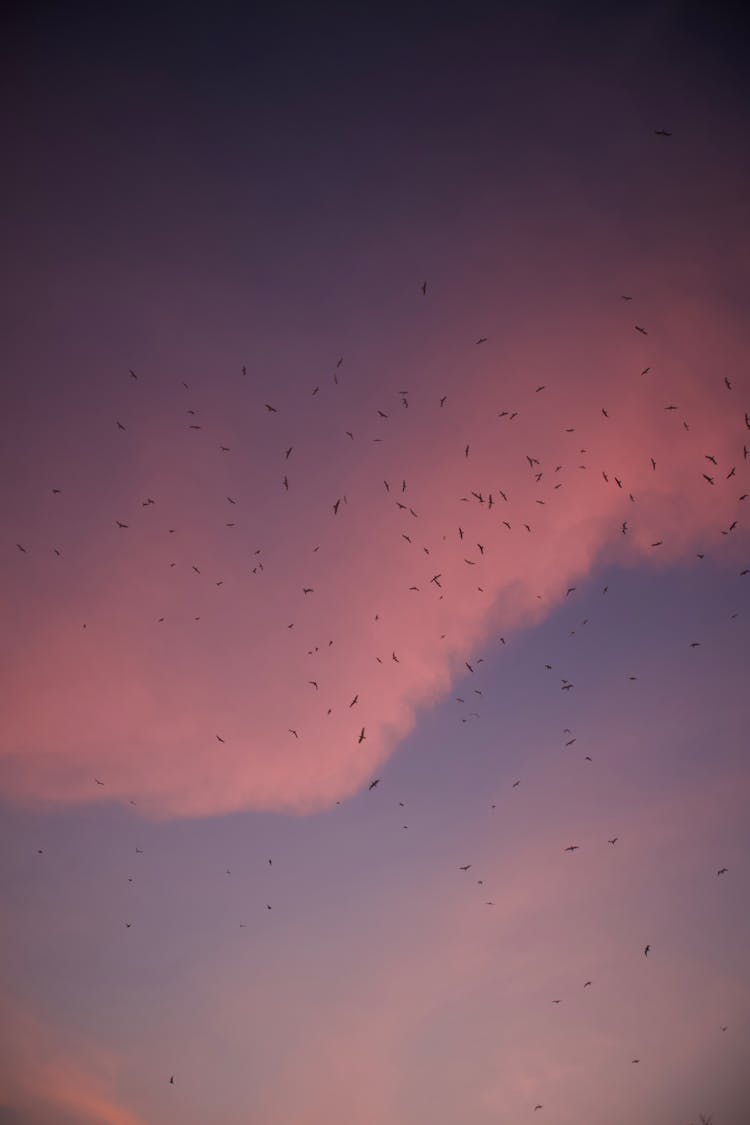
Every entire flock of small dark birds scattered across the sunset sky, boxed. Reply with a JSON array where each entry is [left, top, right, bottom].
[[8, 129, 750, 1112]]
